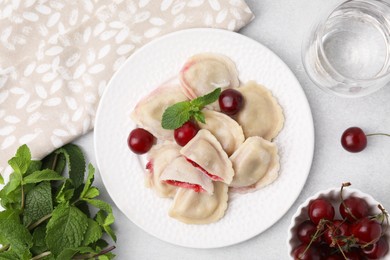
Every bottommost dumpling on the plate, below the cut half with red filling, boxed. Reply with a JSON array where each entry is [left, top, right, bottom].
[[168, 182, 228, 224]]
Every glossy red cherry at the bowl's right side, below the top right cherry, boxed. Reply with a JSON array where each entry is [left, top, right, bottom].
[[351, 217, 382, 244]]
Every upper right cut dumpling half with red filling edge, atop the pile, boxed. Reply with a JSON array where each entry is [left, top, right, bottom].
[[180, 129, 234, 184]]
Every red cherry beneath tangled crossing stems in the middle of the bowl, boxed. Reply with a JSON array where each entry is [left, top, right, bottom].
[[323, 220, 351, 247]]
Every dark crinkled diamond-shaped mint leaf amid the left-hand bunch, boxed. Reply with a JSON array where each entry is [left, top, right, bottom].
[[23, 182, 53, 226]]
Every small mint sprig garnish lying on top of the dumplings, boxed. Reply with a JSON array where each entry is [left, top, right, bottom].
[[161, 88, 221, 129]]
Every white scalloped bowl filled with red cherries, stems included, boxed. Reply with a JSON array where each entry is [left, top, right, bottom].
[[287, 183, 390, 260]]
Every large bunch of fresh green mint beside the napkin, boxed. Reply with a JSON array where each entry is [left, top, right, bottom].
[[0, 144, 116, 260]]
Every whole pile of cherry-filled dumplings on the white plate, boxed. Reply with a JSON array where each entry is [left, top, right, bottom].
[[131, 53, 284, 224]]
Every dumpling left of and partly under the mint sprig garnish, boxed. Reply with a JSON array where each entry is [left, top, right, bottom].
[[131, 80, 188, 140]]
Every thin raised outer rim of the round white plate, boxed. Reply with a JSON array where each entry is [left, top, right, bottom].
[[93, 28, 315, 249]]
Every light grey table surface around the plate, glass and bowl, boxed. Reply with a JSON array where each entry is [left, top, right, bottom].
[[75, 0, 390, 260]]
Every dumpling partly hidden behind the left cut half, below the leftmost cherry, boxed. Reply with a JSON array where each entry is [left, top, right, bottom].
[[145, 142, 181, 198]]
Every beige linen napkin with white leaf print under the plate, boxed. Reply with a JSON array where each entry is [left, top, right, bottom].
[[0, 0, 254, 173]]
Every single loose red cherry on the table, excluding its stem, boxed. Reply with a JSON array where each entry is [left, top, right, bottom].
[[341, 127, 367, 153]]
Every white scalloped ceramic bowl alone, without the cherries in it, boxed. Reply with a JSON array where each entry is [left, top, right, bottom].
[[287, 187, 390, 260]]
